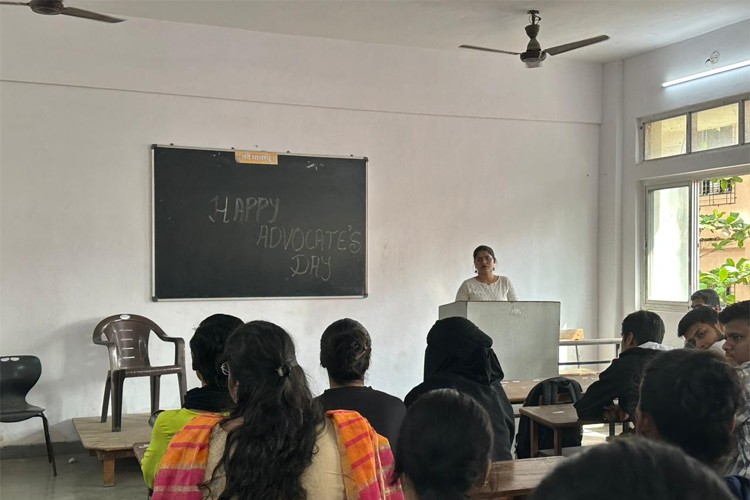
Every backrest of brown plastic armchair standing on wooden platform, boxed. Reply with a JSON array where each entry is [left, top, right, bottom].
[[94, 314, 166, 370]]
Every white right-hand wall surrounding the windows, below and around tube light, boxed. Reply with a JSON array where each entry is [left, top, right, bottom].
[[599, 20, 750, 345]]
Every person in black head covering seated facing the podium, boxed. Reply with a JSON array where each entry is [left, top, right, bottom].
[[404, 318, 516, 460]]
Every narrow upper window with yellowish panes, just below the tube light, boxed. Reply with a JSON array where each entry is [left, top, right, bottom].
[[641, 97, 750, 161]]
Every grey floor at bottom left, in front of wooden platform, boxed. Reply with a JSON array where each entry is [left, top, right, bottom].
[[0, 453, 147, 500]]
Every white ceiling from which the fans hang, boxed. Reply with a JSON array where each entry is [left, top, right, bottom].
[[11, 0, 750, 62]]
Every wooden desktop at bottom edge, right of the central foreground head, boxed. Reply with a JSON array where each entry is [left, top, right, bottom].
[[471, 457, 565, 499]]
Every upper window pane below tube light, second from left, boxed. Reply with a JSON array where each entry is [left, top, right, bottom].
[[690, 103, 740, 151]]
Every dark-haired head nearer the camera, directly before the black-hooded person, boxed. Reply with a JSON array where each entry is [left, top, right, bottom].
[[395, 389, 493, 500]]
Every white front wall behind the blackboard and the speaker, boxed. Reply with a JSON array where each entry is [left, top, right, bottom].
[[0, 9, 602, 445]]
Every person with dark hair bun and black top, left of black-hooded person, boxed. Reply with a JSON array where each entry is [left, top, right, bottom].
[[316, 318, 406, 452]]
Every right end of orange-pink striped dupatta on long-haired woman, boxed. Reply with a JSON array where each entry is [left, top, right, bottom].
[[326, 410, 404, 500]]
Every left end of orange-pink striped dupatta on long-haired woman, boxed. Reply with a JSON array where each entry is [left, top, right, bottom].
[[151, 413, 224, 500]]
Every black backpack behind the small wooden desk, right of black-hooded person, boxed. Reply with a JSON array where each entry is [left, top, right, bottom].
[[516, 377, 583, 458]]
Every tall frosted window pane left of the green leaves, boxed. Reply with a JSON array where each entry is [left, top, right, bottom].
[[646, 186, 690, 302]]
